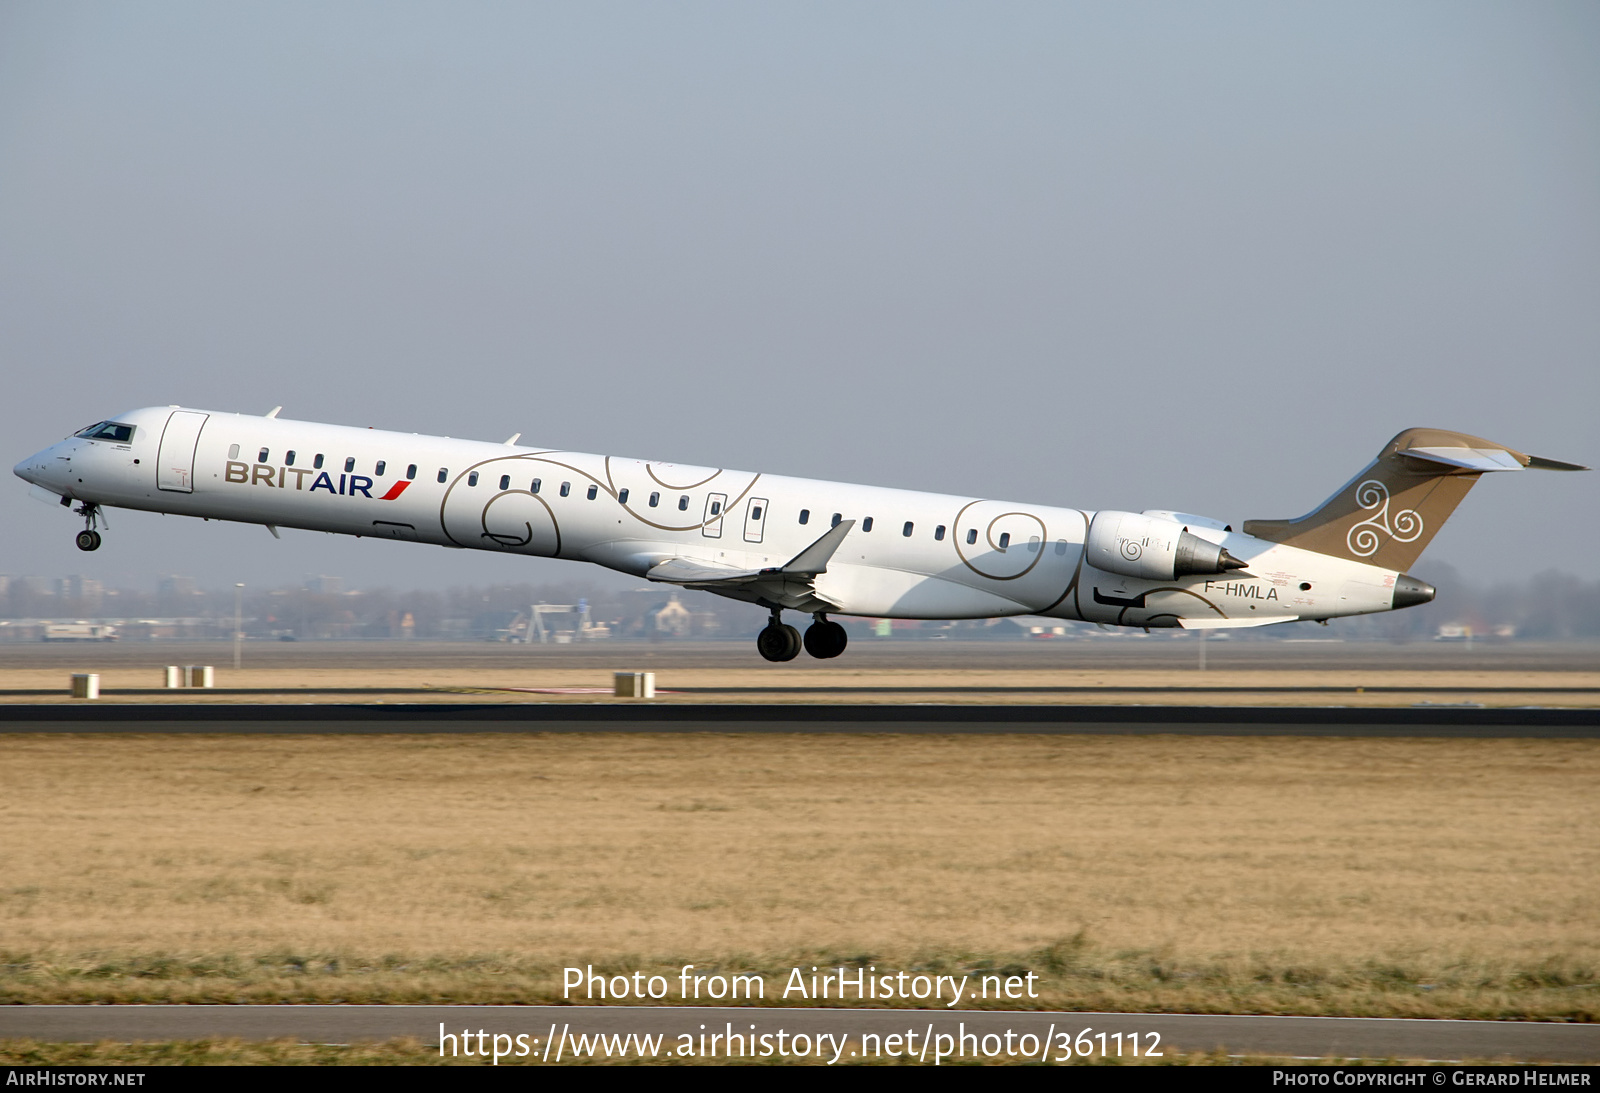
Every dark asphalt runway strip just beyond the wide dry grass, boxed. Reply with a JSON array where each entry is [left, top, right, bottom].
[[0, 703, 1600, 739]]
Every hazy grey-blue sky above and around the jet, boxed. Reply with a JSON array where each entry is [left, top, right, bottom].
[[0, 0, 1600, 587]]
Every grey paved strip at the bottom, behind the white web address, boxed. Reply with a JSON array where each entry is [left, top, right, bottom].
[[0, 1005, 1600, 1063]]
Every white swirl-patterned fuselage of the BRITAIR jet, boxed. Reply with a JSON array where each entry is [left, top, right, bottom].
[[16, 406, 1430, 659]]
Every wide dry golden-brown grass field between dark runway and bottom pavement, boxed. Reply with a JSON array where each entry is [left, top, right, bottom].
[[0, 735, 1600, 1019]]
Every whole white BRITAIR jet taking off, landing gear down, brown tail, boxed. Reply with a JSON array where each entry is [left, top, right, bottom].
[[16, 406, 1586, 661]]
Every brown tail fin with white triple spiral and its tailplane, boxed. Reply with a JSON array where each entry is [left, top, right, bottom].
[[1245, 429, 1589, 573]]
